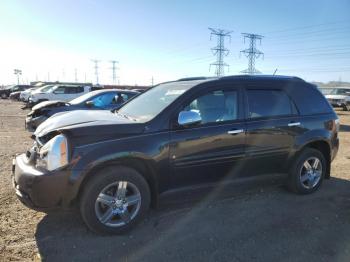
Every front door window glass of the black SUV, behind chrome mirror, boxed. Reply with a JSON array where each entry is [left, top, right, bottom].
[[184, 90, 238, 124]]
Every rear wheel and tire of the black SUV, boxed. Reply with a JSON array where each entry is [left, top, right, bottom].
[[287, 148, 327, 194]]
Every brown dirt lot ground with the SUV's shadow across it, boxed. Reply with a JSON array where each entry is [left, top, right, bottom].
[[0, 100, 350, 261]]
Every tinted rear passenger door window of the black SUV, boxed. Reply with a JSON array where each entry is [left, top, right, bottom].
[[247, 90, 292, 118]]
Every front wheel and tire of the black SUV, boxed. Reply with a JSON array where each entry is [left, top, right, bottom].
[[80, 166, 151, 234]]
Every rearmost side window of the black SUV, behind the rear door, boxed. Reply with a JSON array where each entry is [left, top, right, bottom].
[[291, 86, 333, 115]]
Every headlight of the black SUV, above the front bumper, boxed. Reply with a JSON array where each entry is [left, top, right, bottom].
[[36, 135, 68, 171]]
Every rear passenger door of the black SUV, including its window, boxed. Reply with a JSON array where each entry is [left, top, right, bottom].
[[245, 85, 300, 176]]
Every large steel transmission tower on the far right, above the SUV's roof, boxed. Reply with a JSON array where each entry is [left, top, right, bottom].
[[241, 33, 264, 75]]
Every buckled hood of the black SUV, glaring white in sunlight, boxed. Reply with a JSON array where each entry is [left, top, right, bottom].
[[34, 110, 138, 137]]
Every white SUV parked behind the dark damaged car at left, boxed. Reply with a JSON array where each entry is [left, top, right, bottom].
[[29, 85, 91, 104]]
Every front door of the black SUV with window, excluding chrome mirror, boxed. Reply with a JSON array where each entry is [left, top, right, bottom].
[[170, 87, 245, 188]]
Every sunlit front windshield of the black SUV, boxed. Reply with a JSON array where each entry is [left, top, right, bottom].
[[117, 81, 198, 122]]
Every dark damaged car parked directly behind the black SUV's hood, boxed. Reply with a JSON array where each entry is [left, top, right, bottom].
[[26, 89, 139, 132]]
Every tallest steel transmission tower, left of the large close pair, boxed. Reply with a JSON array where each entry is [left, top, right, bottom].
[[209, 27, 232, 76]]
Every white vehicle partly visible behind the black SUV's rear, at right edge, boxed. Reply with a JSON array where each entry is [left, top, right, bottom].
[[320, 87, 350, 111]]
